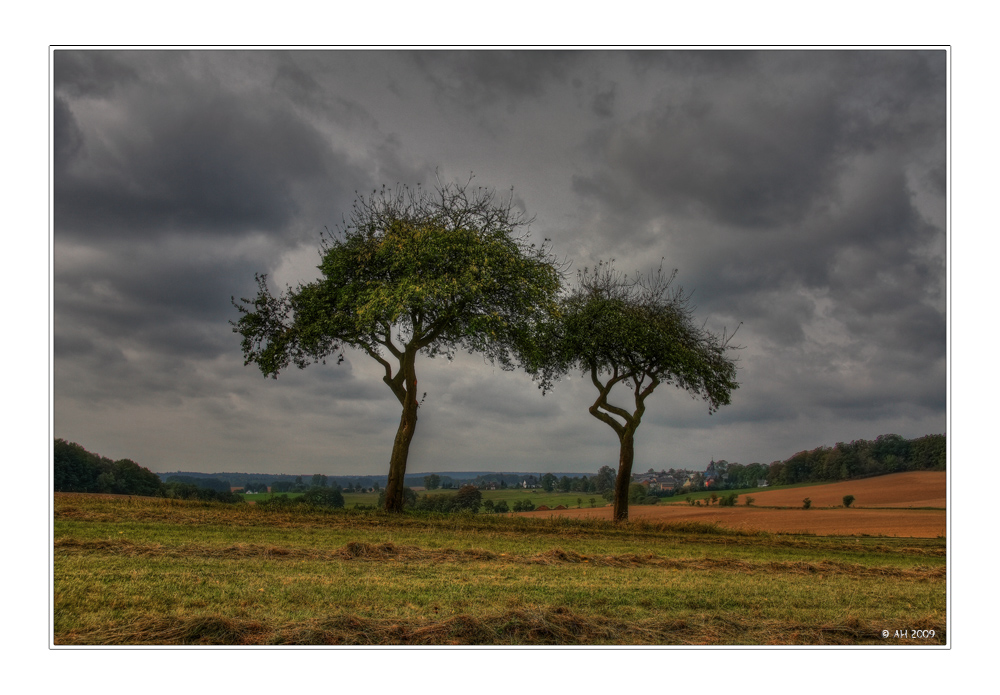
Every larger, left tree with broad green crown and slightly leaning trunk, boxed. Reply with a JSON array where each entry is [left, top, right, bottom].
[[233, 181, 560, 511]]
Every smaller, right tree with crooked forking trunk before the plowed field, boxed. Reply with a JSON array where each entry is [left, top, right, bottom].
[[528, 262, 739, 521]]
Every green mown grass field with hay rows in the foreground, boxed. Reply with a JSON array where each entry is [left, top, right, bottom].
[[53, 491, 946, 646]]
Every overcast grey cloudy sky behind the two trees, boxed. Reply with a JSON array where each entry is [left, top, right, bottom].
[[52, 50, 948, 474]]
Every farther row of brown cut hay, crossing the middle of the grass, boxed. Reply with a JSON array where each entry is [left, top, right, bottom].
[[55, 538, 946, 581]]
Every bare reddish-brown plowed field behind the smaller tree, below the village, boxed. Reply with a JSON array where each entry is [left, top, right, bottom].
[[522, 471, 947, 538]]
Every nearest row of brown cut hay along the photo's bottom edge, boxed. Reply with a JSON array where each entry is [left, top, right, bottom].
[[56, 608, 946, 646]]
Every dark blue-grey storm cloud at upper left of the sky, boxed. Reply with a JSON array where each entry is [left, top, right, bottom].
[[55, 94, 336, 242]]
